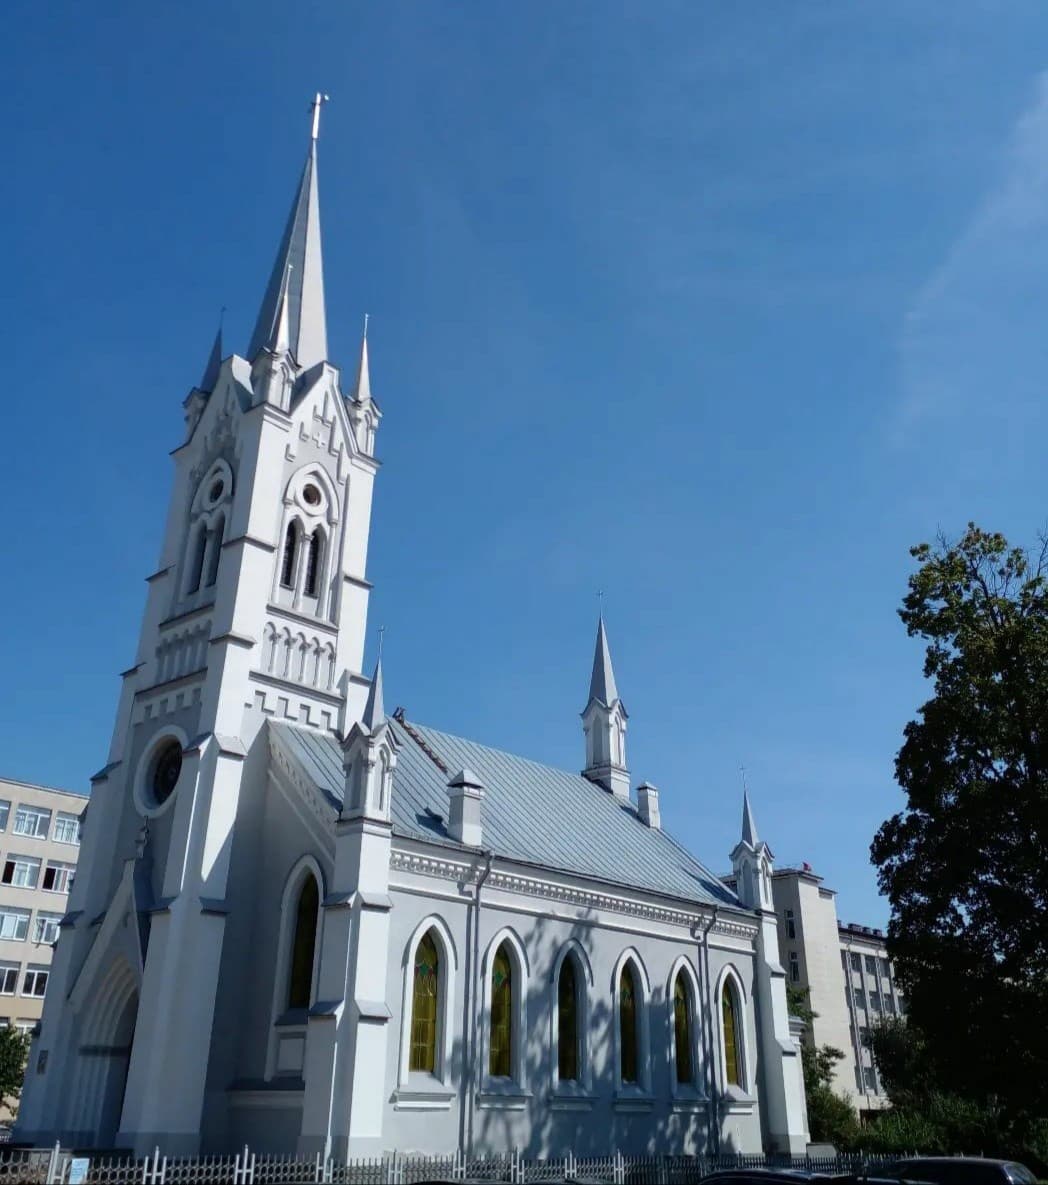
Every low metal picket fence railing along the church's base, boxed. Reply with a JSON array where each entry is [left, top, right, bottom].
[[0, 1145, 896, 1185]]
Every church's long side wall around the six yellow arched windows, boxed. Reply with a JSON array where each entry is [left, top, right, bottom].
[[383, 877, 761, 1157]]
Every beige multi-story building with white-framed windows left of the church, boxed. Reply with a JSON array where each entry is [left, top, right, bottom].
[[0, 779, 87, 1057]]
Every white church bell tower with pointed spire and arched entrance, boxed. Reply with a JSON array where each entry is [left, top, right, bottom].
[[19, 95, 382, 1154]]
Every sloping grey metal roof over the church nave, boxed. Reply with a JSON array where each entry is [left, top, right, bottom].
[[269, 717, 743, 909]]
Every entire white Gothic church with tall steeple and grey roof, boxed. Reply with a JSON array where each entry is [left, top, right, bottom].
[[15, 96, 807, 1158]]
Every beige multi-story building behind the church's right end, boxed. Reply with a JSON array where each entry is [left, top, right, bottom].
[[727, 864, 906, 1114]]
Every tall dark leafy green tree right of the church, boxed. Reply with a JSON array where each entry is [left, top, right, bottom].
[[871, 524, 1048, 1116]]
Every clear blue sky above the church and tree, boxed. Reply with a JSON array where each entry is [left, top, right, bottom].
[[0, 0, 1048, 924]]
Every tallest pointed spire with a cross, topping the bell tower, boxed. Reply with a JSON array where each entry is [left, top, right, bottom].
[[248, 94, 327, 369]]
